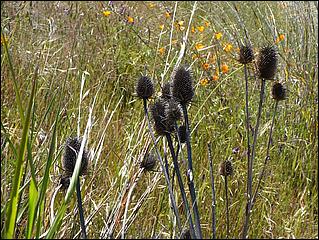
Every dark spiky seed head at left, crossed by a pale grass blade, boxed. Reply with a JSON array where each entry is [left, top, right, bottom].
[[62, 137, 88, 176]]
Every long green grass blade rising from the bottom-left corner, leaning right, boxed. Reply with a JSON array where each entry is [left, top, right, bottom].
[[5, 77, 36, 238]]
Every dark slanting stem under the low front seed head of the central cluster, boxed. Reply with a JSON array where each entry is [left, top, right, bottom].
[[166, 133, 195, 237]]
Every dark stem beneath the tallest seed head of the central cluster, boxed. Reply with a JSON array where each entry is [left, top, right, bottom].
[[182, 104, 202, 239]]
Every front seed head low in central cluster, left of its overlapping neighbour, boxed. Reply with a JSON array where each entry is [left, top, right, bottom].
[[151, 99, 174, 136]]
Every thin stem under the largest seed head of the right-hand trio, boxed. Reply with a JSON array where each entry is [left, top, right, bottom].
[[242, 79, 266, 239]]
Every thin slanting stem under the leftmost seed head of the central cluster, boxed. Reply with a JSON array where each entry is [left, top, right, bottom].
[[143, 98, 182, 233]]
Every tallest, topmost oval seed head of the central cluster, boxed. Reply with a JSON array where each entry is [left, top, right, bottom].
[[172, 66, 195, 105]]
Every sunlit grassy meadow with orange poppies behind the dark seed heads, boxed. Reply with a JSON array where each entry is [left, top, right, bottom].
[[1, 1, 318, 238]]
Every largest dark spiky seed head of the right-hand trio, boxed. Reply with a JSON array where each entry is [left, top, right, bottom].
[[257, 46, 278, 80]]
